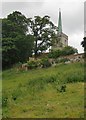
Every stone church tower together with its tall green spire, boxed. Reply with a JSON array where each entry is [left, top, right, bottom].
[[52, 9, 68, 50]]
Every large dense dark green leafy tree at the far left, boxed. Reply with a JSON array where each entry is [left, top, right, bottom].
[[2, 11, 34, 67]]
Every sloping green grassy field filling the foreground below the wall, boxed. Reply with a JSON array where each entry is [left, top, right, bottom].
[[2, 63, 84, 118]]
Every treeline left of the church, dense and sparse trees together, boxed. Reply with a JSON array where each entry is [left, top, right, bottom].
[[2, 11, 57, 68]]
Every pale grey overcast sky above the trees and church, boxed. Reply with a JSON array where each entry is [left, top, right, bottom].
[[0, 0, 85, 53]]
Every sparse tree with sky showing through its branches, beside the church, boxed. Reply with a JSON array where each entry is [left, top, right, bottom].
[[28, 16, 56, 57]]
